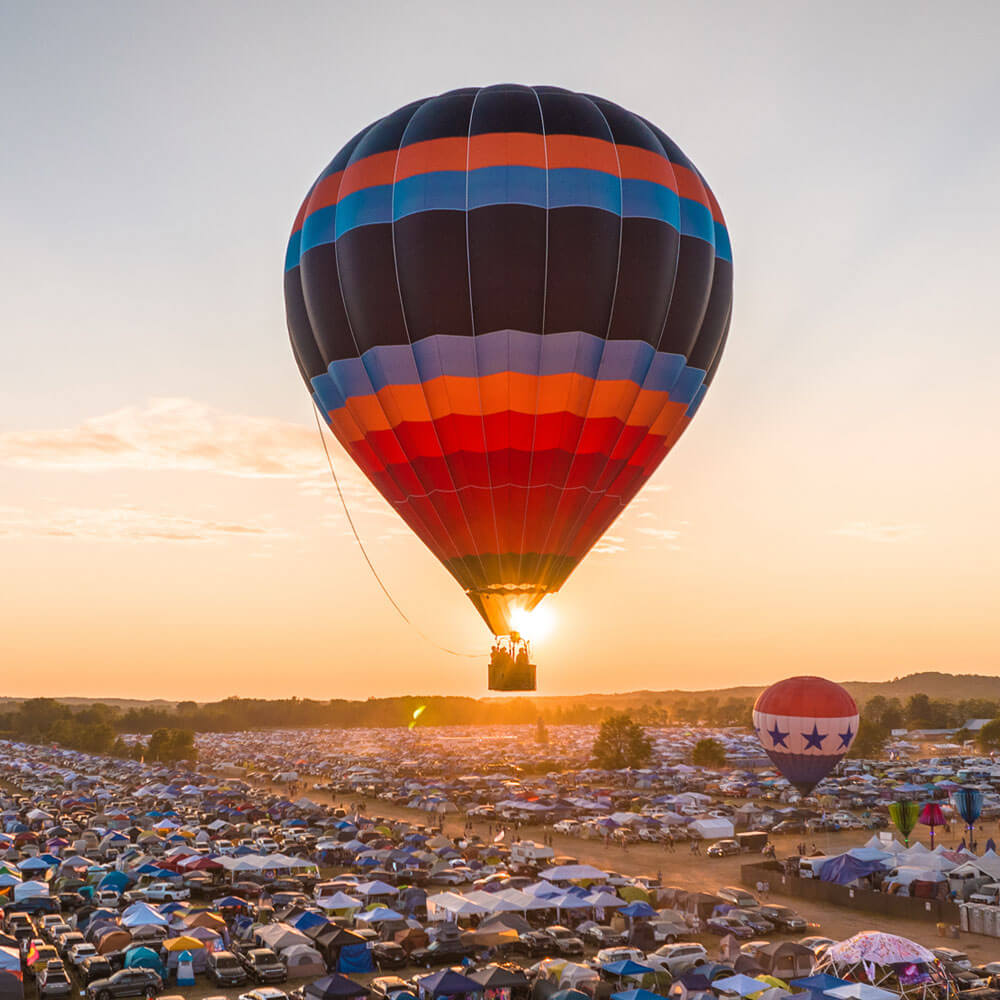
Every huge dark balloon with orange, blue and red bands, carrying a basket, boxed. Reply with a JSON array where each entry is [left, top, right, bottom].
[[285, 84, 733, 690]]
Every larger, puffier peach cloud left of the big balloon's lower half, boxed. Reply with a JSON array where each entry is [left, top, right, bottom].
[[0, 399, 325, 477]]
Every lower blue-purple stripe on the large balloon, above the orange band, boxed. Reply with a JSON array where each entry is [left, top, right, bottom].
[[313, 330, 705, 409]]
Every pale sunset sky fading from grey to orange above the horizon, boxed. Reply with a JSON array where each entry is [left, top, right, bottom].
[[0, 0, 1000, 700]]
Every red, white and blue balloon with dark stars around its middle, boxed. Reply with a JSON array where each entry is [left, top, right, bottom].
[[753, 677, 858, 795]]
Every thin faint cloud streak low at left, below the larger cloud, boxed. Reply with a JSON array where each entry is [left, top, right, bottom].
[[0, 506, 285, 542]]
